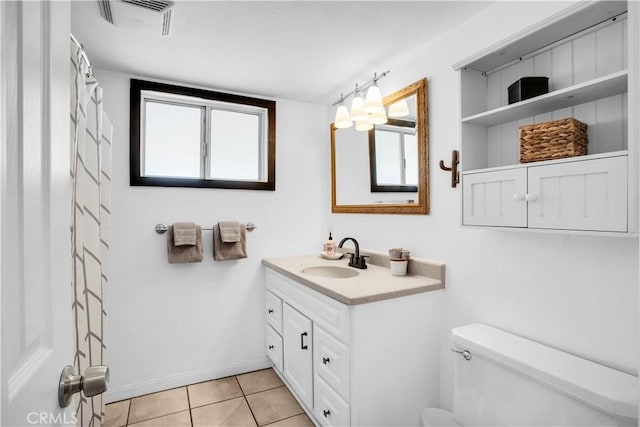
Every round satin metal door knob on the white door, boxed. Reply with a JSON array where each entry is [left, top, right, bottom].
[[58, 365, 109, 408]]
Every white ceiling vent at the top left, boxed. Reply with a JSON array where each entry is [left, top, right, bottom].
[[98, 0, 173, 36]]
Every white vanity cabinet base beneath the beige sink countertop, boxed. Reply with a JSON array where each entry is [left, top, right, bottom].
[[265, 267, 442, 426]]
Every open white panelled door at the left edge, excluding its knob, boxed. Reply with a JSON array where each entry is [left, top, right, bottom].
[[0, 2, 77, 426]]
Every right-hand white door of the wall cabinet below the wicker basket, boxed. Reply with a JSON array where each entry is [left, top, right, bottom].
[[527, 156, 627, 231]]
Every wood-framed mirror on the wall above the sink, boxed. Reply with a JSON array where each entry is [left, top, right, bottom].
[[331, 78, 429, 215]]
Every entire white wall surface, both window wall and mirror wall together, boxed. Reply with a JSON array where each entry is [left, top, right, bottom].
[[96, 2, 639, 416]]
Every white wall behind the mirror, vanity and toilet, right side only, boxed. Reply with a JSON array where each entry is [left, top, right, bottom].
[[327, 2, 639, 409]]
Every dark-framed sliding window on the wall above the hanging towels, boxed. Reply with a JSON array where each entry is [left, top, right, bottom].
[[129, 79, 276, 190]]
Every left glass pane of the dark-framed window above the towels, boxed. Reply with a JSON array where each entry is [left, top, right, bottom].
[[144, 102, 202, 178]]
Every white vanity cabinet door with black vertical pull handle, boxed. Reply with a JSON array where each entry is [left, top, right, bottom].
[[282, 303, 313, 408]]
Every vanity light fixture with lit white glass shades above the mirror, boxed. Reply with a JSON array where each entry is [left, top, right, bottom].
[[333, 71, 392, 131]]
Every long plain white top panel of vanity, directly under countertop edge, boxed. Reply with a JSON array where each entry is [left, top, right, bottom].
[[265, 268, 350, 344]]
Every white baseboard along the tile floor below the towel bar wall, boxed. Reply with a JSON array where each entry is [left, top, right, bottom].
[[103, 356, 273, 403]]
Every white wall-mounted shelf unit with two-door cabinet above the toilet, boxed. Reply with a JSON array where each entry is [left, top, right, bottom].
[[454, 2, 640, 235]]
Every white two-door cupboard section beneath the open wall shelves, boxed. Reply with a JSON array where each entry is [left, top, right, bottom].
[[462, 153, 628, 232]]
